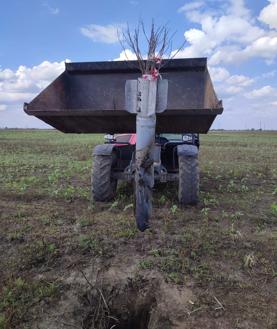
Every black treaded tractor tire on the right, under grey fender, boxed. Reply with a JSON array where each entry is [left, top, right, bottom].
[[179, 156, 199, 206]]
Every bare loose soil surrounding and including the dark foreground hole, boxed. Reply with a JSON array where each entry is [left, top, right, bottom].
[[35, 258, 193, 329]]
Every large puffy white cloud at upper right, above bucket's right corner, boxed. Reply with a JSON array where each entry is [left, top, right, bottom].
[[176, 0, 277, 65]]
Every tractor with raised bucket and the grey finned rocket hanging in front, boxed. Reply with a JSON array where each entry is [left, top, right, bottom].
[[24, 56, 223, 231]]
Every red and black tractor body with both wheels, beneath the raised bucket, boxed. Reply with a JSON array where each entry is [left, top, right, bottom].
[[92, 134, 199, 205]]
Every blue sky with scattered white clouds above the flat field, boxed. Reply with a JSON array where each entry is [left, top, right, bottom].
[[0, 0, 277, 130]]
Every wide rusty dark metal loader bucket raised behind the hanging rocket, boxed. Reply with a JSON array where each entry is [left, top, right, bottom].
[[24, 58, 223, 133]]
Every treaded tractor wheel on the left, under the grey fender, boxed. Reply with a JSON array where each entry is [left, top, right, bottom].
[[91, 155, 117, 202]]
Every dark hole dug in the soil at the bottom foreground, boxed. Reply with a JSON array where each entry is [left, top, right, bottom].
[[83, 282, 156, 329]]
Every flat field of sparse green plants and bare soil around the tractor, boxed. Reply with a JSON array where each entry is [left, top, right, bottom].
[[0, 130, 277, 329]]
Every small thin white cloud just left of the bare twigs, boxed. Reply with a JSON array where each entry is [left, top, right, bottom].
[[80, 24, 125, 44]]
